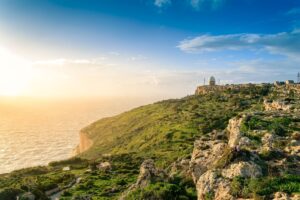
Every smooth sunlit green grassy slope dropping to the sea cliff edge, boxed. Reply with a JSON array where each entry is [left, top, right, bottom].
[[80, 84, 268, 167]]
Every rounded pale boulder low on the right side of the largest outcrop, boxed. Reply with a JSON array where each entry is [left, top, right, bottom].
[[222, 161, 262, 179]]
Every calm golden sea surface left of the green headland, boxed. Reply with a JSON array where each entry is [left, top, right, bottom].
[[0, 99, 155, 174]]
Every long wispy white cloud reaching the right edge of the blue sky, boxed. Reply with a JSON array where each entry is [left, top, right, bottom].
[[177, 30, 300, 57]]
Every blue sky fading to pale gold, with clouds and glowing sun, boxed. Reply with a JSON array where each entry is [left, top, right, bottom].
[[0, 0, 300, 98]]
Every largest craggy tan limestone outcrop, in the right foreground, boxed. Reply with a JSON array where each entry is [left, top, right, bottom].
[[190, 116, 262, 200]]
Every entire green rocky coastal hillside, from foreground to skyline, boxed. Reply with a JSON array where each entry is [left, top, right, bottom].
[[0, 84, 300, 199]]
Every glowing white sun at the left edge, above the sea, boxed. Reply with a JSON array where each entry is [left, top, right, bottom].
[[0, 47, 32, 96]]
